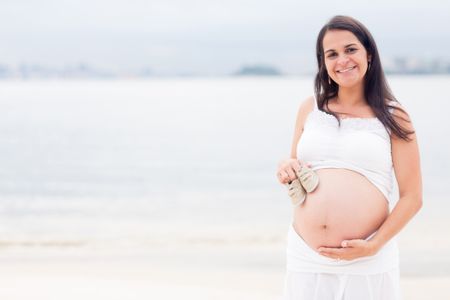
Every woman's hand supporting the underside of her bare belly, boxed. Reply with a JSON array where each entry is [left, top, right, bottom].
[[318, 239, 378, 260]]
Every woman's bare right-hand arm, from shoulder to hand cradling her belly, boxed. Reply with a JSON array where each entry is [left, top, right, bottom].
[[318, 106, 422, 260]]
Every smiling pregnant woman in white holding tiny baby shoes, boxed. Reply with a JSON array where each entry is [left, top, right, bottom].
[[277, 16, 422, 300]]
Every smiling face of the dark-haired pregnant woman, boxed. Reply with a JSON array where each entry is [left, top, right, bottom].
[[322, 30, 370, 87]]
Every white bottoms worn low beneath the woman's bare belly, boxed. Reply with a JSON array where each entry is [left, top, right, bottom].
[[283, 226, 401, 300]]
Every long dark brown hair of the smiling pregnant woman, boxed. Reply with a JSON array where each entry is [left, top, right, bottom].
[[314, 16, 414, 141]]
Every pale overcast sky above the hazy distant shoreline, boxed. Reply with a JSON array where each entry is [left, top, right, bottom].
[[0, 0, 450, 75]]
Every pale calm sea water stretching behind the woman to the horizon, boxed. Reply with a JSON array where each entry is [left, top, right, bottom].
[[0, 76, 450, 265]]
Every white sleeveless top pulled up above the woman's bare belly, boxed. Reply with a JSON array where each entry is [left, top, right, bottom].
[[297, 97, 393, 201]]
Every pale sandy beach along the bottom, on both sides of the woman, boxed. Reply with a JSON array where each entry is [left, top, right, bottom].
[[0, 204, 450, 300]]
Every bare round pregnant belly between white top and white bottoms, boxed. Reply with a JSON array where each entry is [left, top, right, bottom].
[[293, 169, 389, 249]]
